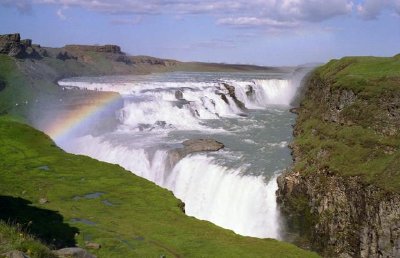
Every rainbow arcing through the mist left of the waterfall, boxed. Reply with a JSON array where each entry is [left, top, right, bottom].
[[44, 92, 121, 142]]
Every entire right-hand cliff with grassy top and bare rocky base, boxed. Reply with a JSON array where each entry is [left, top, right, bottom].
[[277, 55, 400, 257]]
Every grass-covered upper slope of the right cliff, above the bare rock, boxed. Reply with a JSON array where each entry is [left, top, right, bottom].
[[295, 56, 400, 193]]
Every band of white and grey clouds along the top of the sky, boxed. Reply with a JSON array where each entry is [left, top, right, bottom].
[[0, 0, 400, 30]]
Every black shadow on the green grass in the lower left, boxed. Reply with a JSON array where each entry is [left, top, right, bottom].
[[0, 196, 79, 248]]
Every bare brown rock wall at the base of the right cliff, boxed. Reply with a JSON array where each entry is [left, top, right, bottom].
[[278, 170, 400, 257]]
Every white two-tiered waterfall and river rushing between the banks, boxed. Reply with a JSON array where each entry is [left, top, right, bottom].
[[53, 69, 308, 238]]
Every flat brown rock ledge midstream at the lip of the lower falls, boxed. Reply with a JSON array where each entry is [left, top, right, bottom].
[[169, 139, 224, 168]]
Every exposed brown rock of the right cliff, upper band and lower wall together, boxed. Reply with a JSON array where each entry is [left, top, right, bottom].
[[277, 63, 400, 257]]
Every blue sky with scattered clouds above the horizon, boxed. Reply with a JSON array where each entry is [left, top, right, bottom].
[[0, 0, 400, 66]]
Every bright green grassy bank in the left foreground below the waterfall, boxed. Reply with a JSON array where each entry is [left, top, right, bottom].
[[0, 116, 317, 257]]
